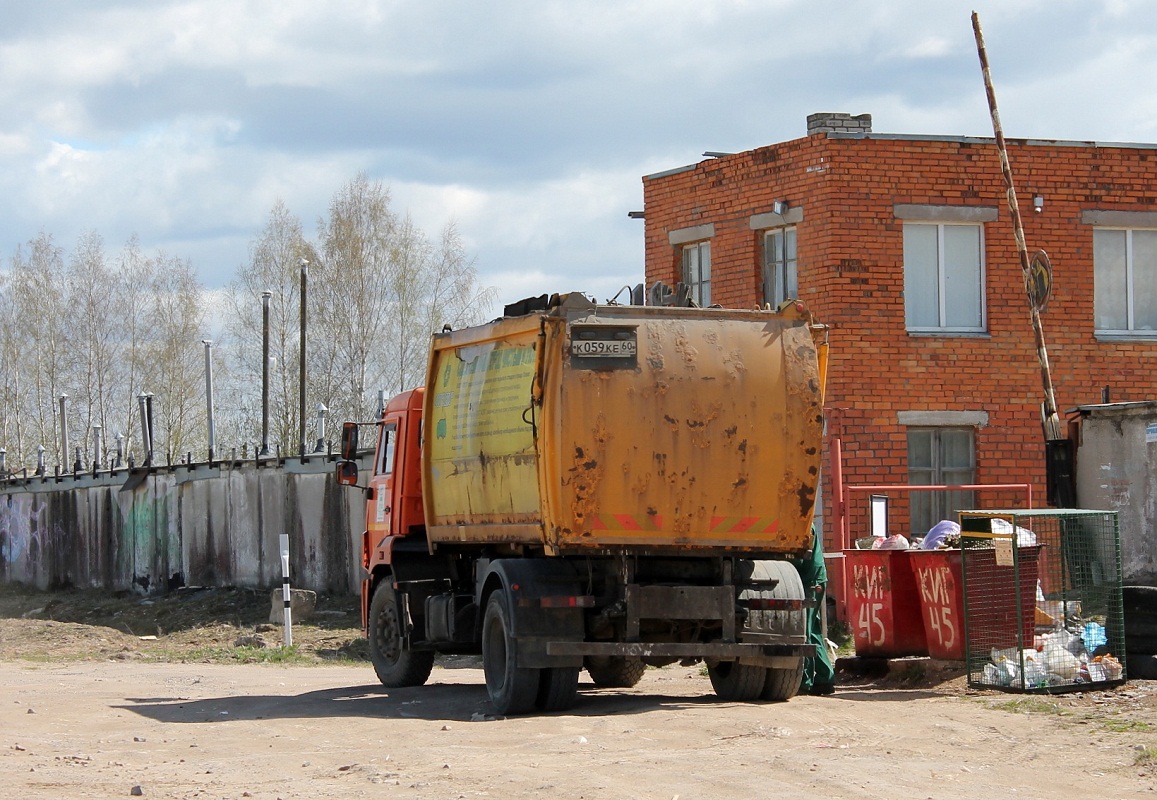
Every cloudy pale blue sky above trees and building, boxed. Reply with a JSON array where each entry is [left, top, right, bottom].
[[0, 0, 1157, 319]]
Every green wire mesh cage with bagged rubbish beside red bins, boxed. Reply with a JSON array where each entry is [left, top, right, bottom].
[[960, 508, 1126, 692]]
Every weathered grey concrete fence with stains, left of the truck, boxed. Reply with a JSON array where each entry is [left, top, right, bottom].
[[0, 455, 364, 594]]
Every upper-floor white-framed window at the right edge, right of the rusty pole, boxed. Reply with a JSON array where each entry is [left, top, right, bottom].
[[1092, 228, 1157, 336]]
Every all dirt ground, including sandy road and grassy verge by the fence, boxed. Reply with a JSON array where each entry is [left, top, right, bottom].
[[0, 589, 1157, 800]]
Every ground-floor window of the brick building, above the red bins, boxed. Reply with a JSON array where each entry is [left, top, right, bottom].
[[908, 427, 977, 536]]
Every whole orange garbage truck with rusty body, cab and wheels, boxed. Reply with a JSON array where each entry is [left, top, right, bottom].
[[337, 293, 827, 714]]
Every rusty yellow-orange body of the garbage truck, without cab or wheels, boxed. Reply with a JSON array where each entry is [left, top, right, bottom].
[[422, 295, 826, 556]]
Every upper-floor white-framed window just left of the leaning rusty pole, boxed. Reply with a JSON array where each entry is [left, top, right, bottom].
[[904, 222, 985, 332]]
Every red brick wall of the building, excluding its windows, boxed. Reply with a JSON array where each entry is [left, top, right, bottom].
[[643, 134, 1157, 543]]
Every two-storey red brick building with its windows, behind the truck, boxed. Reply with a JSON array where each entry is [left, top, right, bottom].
[[643, 113, 1157, 545]]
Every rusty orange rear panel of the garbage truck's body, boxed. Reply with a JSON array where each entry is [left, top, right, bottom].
[[540, 307, 823, 552]]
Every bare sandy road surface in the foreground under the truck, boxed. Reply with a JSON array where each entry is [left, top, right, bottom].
[[0, 662, 1157, 800]]
